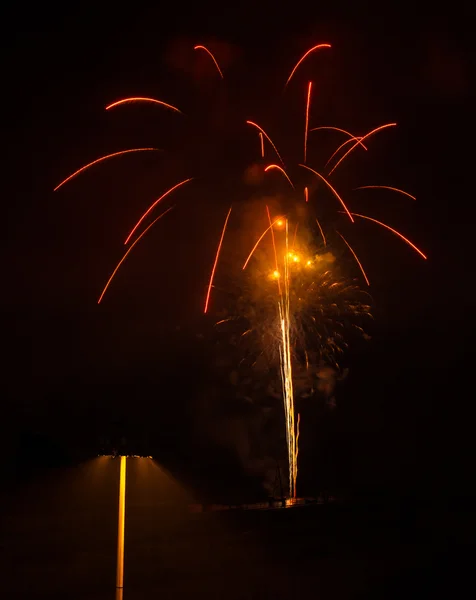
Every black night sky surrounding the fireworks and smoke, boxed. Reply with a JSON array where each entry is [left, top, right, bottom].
[[2, 5, 474, 502]]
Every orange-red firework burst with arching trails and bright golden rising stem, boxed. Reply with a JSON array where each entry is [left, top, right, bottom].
[[54, 43, 426, 498]]
